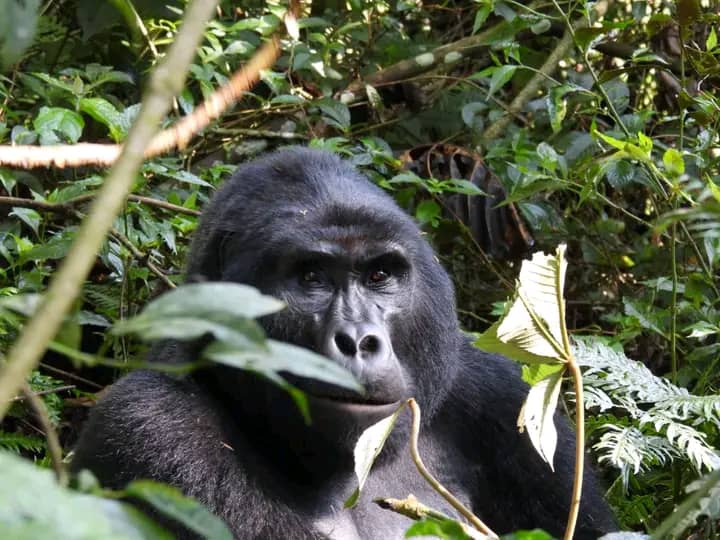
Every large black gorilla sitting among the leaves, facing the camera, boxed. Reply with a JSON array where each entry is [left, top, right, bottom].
[[72, 148, 614, 540]]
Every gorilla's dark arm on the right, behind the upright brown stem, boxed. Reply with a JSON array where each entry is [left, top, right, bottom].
[[448, 345, 617, 540]]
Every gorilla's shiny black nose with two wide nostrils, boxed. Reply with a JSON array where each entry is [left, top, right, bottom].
[[326, 324, 390, 362]]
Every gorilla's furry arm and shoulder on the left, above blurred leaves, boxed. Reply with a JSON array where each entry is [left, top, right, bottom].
[[72, 371, 317, 540]]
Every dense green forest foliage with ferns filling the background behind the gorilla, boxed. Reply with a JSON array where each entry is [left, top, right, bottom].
[[0, 0, 720, 538]]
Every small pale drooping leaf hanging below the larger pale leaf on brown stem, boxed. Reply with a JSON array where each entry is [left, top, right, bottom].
[[518, 366, 565, 470]]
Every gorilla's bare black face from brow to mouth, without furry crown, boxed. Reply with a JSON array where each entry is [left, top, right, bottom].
[[219, 208, 415, 419]]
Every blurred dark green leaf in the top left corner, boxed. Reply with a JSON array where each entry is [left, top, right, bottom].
[[0, 0, 40, 68]]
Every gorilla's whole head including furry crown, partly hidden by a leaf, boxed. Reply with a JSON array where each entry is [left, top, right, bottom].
[[188, 149, 461, 448]]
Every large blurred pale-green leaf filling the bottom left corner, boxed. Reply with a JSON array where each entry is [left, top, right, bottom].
[[0, 452, 172, 540]]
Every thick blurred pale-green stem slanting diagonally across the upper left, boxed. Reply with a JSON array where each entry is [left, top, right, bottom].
[[0, 0, 222, 420]]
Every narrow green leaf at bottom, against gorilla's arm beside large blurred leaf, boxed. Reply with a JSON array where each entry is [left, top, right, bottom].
[[124, 480, 233, 540]]
